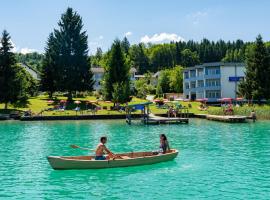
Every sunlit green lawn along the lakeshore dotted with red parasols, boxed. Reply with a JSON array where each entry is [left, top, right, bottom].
[[5, 95, 270, 119]]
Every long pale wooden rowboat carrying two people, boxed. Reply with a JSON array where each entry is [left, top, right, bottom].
[[48, 149, 178, 169]]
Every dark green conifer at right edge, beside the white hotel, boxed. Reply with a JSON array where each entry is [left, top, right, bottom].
[[239, 35, 270, 101]]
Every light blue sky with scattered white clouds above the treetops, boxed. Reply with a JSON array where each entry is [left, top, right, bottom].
[[0, 0, 270, 53]]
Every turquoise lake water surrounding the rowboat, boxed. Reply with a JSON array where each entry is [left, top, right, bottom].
[[0, 120, 270, 200]]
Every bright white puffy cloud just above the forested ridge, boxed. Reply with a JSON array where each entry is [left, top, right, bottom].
[[141, 33, 185, 43]]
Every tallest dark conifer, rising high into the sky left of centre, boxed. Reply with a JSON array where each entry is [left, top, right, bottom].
[[51, 8, 94, 99]]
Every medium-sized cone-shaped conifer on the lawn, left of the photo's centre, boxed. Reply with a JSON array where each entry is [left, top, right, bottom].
[[103, 39, 130, 101]]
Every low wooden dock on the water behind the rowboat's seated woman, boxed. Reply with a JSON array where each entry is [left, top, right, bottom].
[[144, 115, 189, 124]]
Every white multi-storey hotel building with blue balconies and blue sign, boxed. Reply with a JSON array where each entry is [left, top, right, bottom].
[[183, 62, 245, 102]]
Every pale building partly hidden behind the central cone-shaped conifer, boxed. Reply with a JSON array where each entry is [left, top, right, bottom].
[[91, 67, 137, 91]]
